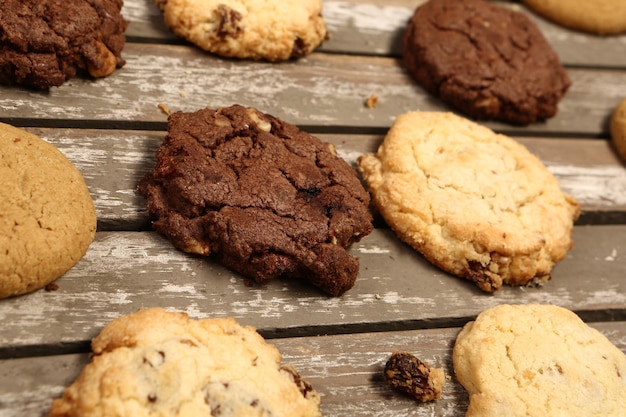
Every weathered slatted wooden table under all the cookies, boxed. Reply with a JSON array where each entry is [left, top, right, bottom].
[[0, 0, 626, 417]]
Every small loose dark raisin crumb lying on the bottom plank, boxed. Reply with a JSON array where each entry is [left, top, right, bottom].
[[383, 352, 445, 402]]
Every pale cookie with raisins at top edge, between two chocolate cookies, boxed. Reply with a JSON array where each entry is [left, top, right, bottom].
[[155, 0, 327, 61]]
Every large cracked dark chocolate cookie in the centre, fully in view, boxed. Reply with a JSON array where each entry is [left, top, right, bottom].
[[138, 105, 372, 296]]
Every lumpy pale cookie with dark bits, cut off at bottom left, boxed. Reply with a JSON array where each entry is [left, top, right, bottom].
[[48, 308, 321, 417]]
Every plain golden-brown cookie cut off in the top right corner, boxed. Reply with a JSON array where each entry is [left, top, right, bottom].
[[522, 0, 626, 35]]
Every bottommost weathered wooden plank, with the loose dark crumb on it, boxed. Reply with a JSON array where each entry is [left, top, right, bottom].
[[0, 322, 626, 417]]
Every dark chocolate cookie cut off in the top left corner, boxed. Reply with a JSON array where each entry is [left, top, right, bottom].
[[0, 0, 127, 89]]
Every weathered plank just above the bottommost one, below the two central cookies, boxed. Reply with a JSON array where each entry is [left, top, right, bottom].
[[0, 226, 626, 357]]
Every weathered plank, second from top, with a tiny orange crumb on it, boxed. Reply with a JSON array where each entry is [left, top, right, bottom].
[[0, 44, 626, 137]]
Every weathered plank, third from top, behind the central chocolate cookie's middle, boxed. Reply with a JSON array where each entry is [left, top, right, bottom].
[[20, 128, 626, 230]]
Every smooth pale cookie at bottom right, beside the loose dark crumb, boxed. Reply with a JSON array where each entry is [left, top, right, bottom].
[[452, 304, 626, 417]]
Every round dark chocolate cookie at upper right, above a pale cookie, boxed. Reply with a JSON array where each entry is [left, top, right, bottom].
[[403, 0, 571, 125]]
